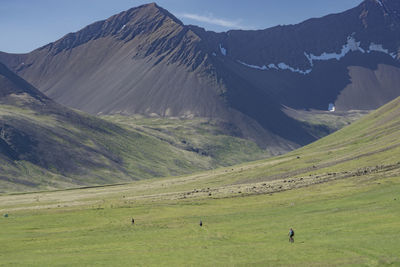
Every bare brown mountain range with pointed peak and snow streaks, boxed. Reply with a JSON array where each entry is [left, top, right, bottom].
[[0, 0, 400, 153]]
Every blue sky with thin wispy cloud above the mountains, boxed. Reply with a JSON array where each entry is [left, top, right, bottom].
[[0, 0, 362, 53]]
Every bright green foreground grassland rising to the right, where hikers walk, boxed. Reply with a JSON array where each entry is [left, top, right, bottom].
[[0, 99, 400, 266]]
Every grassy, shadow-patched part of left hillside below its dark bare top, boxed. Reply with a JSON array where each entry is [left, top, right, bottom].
[[0, 101, 216, 192]]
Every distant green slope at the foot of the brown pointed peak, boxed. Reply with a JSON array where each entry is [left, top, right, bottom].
[[101, 115, 271, 167]]
